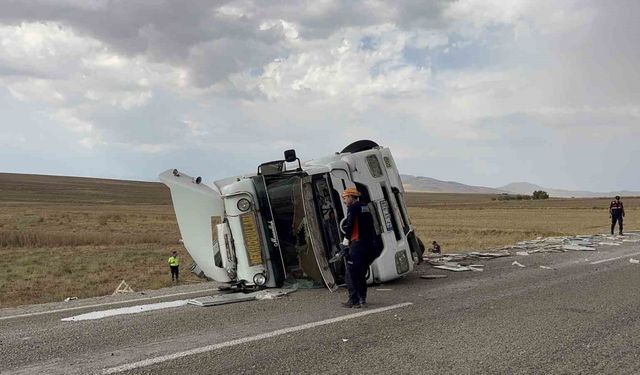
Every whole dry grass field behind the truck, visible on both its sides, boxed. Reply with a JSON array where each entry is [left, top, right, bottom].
[[0, 173, 640, 307]]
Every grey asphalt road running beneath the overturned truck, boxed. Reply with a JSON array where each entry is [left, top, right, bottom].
[[0, 238, 640, 374]]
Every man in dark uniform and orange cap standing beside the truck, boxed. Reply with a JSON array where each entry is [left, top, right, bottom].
[[342, 188, 381, 308]]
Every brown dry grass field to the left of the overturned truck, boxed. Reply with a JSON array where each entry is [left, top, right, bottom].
[[0, 173, 200, 307]]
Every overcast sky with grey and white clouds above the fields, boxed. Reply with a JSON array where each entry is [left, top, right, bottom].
[[0, 0, 640, 191]]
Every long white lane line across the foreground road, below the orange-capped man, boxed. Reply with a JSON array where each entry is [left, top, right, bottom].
[[102, 302, 413, 375]]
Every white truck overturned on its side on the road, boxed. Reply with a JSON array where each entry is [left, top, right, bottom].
[[160, 140, 424, 291]]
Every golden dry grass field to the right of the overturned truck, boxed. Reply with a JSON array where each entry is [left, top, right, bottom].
[[406, 193, 640, 252]]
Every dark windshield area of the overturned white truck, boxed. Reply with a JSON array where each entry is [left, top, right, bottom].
[[265, 176, 323, 287]]
